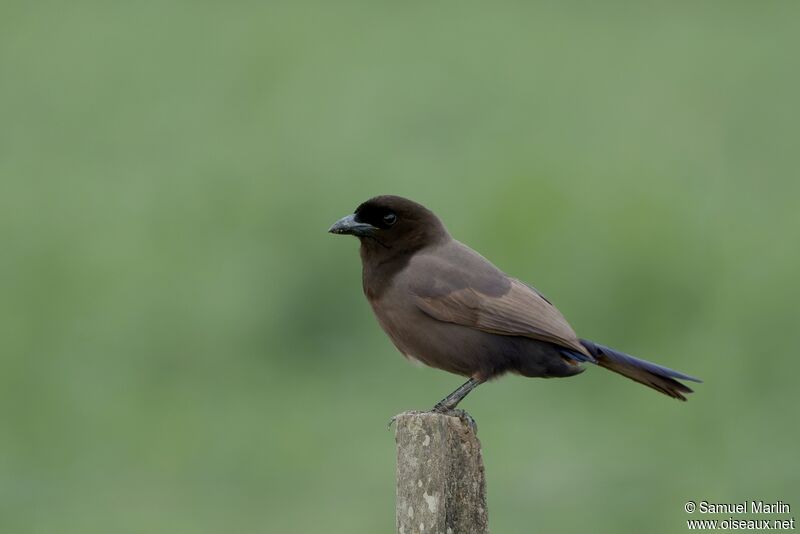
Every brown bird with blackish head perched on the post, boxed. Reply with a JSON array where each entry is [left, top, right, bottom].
[[328, 195, 702, 413]]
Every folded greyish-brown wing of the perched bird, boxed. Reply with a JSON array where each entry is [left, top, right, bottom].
[[412, 246, 591, 358]]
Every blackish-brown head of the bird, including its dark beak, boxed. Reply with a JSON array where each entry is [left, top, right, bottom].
[[328, 195, 450, 252]]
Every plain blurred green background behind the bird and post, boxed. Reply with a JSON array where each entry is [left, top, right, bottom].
[[0, 0, 800, 533]]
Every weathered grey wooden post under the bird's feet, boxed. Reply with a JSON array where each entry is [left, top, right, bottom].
[[395, 410, 489, 534]]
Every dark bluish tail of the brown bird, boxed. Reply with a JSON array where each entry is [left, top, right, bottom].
[[580, 339, 702, 401]]
